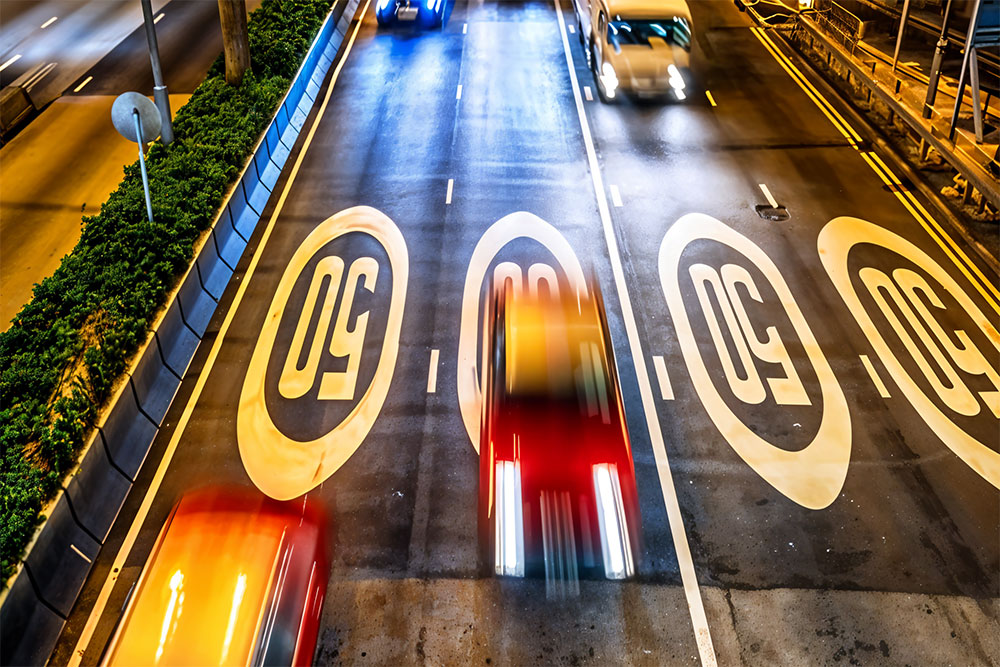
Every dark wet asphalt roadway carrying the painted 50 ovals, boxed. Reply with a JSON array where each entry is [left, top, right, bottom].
[[52, 2, 1000, 665]]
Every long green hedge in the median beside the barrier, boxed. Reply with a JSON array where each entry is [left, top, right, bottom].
[[0, 0, 332, 581]]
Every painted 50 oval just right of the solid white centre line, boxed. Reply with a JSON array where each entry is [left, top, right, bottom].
[[659, 213, 851, 509]]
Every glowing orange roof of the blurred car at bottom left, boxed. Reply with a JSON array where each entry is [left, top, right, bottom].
[[102, 493, 299, 665]]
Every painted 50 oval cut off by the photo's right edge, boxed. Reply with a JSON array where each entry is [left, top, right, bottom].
[[817, 217, 1000, 488]]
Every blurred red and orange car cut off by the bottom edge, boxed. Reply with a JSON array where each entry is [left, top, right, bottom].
[[104, 488, 328, 665]]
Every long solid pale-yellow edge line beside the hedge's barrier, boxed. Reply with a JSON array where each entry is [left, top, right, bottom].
[[68, 0, 371, 667]]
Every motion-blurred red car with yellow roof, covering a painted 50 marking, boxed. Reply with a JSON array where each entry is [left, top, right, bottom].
[[479, 280, 640, 592]]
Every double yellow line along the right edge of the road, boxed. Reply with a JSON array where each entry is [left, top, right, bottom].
[[750, 27, 1000, 314]]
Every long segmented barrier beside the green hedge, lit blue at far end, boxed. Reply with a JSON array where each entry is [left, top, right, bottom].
[[0, 0, 358, 665]]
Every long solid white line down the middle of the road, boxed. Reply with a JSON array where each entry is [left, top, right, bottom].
[[554, 0, 717, 667]]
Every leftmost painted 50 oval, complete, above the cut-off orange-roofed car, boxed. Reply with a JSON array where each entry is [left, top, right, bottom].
[[236, 206, 409, 499]]
